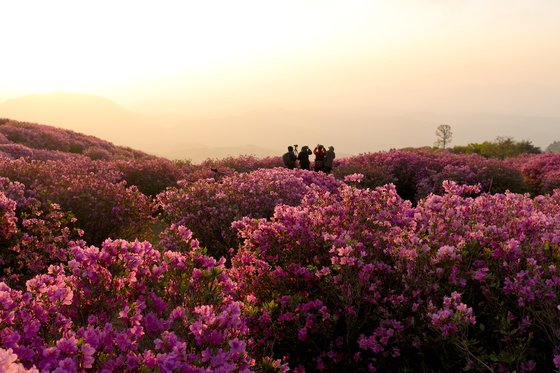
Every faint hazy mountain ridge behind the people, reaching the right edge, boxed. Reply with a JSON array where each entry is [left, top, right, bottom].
[[172, 108, 560, 157]]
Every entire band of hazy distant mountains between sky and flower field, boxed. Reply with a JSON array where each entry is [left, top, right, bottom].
[[0, 93, 560, 162]]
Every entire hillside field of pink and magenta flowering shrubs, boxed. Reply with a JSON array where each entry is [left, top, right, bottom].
[[0, 120, 560, 372]]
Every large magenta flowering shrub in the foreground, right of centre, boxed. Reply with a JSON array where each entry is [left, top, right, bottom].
[[231, 183, 422, 371]]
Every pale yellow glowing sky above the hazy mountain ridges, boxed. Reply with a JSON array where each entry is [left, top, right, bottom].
[[0, 0, 560, 106]]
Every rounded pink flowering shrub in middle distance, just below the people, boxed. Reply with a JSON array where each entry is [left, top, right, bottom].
[[158, 168, 339, 257]]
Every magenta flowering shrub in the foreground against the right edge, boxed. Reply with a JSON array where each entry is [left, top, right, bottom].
[[415, 184, 560, 371]]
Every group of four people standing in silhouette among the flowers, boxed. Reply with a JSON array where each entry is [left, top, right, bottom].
[[282, 144, 335, 173]]
